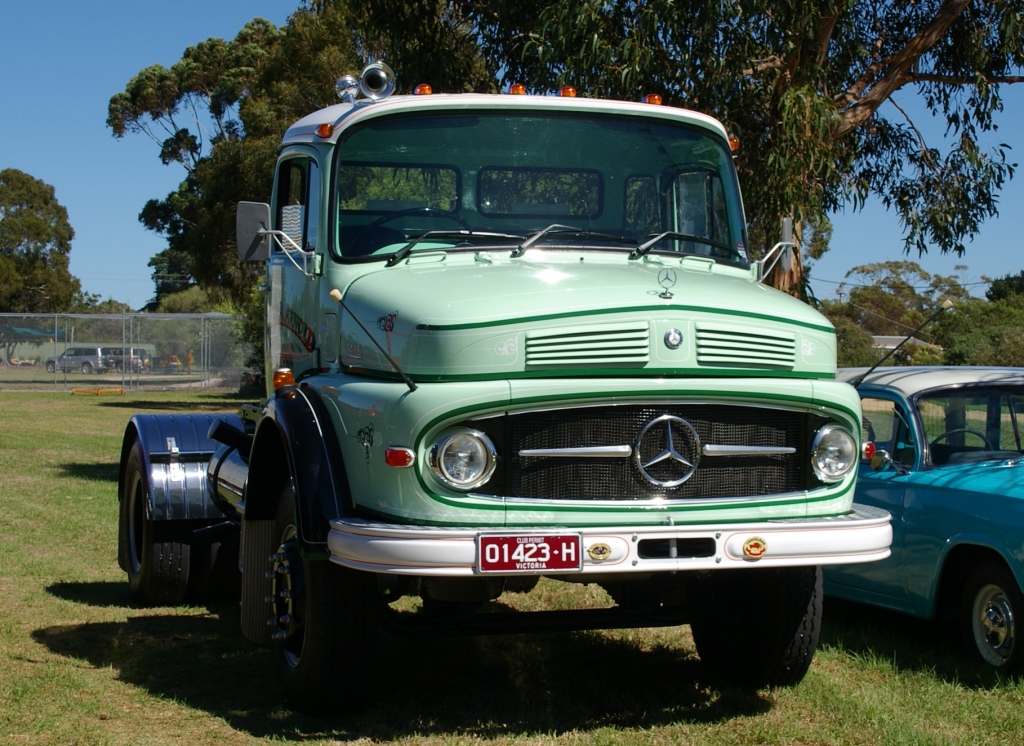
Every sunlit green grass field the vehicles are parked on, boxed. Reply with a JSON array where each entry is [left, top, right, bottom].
[[0, 392, 1024, 746]]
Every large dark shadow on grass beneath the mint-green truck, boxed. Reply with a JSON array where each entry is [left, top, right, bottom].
[[33, 583, 771, 742]]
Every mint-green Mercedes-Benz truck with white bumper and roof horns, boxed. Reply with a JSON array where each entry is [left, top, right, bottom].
[[121, 63, 891, 710]]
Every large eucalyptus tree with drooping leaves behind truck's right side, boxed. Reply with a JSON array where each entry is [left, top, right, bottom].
[[464, 0, 1024, 292]]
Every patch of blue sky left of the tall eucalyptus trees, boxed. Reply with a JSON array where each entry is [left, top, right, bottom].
[[0, 0, 299, 308]]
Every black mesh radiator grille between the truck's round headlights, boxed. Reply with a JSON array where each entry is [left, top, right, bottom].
[[488, 404, 807, 500]]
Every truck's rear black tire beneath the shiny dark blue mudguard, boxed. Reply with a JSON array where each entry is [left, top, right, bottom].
[[120, 440, 190, 606]]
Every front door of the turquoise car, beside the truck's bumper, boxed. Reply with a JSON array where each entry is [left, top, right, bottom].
[[826, 391, 922, 611]]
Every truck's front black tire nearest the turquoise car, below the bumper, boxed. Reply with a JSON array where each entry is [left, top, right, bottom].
[[690, 567, 822, 689]]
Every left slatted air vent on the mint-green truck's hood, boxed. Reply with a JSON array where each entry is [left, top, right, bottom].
[[526, 321, 650, 367]]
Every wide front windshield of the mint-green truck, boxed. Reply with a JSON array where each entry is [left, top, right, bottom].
[[332, 112, 746, 265]]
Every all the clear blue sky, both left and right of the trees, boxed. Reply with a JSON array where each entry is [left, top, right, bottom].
[[0, 0, 1024, 308]]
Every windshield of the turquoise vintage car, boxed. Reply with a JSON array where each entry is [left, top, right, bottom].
[[916, 386, 1024, 466]]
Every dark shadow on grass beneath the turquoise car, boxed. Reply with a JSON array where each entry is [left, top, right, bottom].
[[819, 598, 1008, 689]]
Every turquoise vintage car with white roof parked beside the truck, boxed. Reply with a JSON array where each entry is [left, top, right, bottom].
[[824, 367, 1024, 673]]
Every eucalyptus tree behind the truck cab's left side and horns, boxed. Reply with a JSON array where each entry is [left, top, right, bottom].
[[106, 0, 495, 309]]
